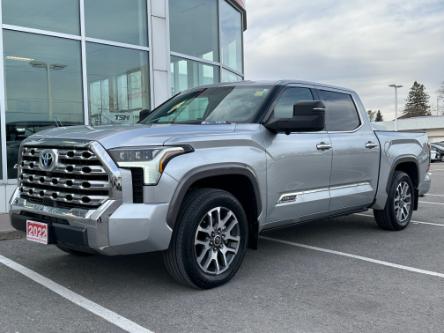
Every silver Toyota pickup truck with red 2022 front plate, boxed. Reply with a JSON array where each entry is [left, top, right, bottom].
[[10, 81, 430, 288]]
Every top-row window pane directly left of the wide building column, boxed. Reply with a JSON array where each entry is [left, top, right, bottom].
[[85, 0, 148, 46]]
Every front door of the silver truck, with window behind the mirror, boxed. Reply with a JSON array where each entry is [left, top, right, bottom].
[[267, 87, 332, 226]]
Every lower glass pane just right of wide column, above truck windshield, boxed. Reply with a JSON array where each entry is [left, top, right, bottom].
[[171, 57, 219, 94]]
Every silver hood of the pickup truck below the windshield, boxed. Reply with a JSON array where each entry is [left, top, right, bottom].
[[30, 124, 236, 149]]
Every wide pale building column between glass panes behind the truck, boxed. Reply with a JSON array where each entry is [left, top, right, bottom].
[[149, 0, 171, 107]]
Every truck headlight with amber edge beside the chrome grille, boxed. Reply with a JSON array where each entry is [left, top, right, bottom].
[[109, 146, 192, 185]]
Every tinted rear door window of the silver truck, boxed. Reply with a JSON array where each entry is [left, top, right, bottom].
[[319, 90, 361, 131]]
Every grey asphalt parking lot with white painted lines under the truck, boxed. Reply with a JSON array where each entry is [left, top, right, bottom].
[[0, 163, 444, 332]]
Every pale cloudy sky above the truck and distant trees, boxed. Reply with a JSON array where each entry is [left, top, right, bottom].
[[245, 0, 444, 120]]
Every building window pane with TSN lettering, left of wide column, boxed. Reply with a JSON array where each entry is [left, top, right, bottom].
[[86, 43, 150, 125]]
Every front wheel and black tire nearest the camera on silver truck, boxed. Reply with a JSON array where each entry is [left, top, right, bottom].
[[163, 188, 248, 289]]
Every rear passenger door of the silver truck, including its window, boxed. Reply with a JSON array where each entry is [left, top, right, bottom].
[[318, 90, 380, 212]]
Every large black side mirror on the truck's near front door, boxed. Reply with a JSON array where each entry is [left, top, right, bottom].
[[265, 101, 325, 134]]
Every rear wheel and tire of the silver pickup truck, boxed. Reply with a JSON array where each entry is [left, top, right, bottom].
[[373, 171, 415, 231]]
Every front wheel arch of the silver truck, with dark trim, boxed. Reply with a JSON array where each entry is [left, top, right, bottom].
[[167, 163, 262, 248]]
